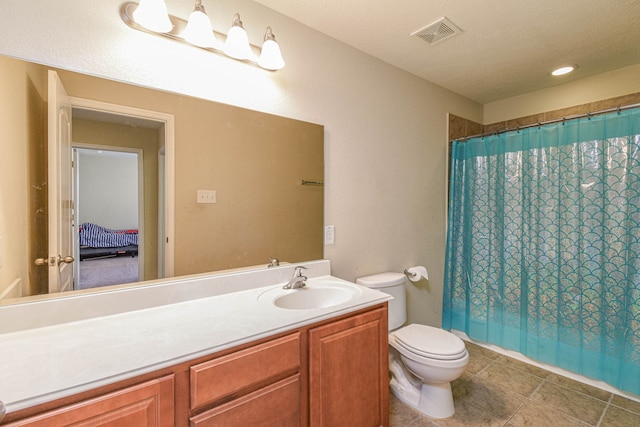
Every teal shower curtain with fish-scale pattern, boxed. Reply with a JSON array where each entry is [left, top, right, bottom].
[[443, 108, 640, 395]]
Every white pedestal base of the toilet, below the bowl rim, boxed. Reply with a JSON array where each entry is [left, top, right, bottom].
[[389, 359, 455, 419]]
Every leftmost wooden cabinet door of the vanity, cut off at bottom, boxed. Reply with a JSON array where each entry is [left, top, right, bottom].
[[7, 375, 174, 427]]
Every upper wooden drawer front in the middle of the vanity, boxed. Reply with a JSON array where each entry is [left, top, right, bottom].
[[189, 332, 300, 410]]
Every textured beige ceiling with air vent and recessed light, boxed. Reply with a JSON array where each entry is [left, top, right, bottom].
[[256, 0, 640, 104]]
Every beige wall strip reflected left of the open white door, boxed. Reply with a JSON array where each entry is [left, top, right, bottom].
[[0, 54, 47, 297]]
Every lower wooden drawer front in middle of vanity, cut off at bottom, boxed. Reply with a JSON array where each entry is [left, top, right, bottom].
[[191, 374, 301, 427]]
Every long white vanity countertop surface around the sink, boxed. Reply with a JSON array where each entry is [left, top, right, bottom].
[[0, 260, 390, 412]]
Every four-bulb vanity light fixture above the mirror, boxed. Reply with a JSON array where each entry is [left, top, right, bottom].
[[120, 0, 284, 71]]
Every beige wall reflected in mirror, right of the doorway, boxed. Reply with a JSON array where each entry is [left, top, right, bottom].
[[170, 103, 324, 275]]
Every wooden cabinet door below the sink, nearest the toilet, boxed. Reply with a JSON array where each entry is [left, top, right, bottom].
[[309, 308, 389, 427]]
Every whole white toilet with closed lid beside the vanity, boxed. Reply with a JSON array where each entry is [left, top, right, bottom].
[[356, 273, 469, 418]]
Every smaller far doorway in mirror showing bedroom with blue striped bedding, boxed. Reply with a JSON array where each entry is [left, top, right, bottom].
[[74, 145, 144, 289]]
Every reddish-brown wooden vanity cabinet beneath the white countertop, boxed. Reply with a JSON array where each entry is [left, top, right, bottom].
[[2, 303, 389, 427]]
